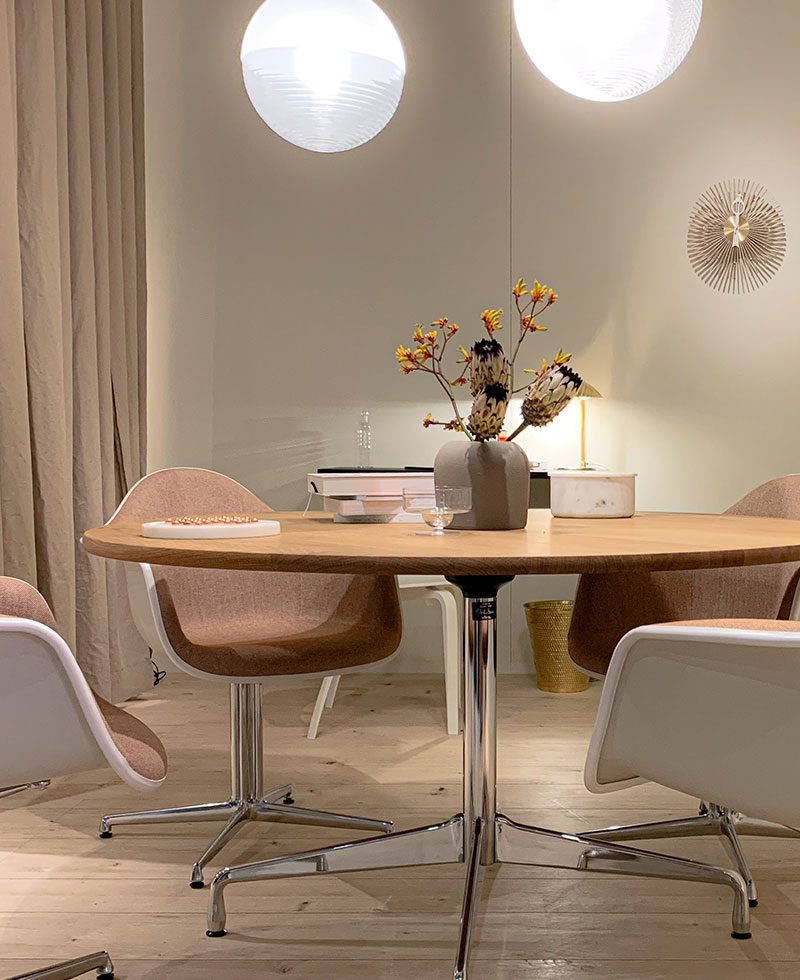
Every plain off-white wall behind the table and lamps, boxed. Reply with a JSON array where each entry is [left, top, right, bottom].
[[145, 0, 800, 669]]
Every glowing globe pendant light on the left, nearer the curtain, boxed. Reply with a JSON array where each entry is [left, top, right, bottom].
[[242, 0, 406, 153]]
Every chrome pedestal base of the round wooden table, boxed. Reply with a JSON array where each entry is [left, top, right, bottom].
[[208, 577, 750, 980]]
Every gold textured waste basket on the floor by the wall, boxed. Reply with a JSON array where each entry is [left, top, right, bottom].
[[525, 599, 589, 694]]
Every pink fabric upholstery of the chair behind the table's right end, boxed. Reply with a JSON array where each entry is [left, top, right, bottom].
[[569, 476, 800, 674]]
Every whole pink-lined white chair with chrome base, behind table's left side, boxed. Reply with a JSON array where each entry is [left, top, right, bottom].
[[100, 468, 402, 888]]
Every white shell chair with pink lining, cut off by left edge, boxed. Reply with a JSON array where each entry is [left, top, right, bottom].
[[0, 577, 167, 980]]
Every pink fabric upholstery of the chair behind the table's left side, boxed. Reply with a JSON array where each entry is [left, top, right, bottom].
[[112, 469, 402, 678]]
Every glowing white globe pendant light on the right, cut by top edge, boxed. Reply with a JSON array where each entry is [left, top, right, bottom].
[[514, 0, 703, 102]]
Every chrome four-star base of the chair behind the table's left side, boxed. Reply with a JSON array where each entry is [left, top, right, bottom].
[[100, 684, 394, 888]]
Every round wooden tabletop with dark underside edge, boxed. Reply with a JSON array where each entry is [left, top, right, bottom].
[[83, 510, 800, 575]]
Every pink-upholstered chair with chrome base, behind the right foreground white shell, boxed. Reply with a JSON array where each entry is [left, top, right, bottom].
[[569, 475, 800, 905]]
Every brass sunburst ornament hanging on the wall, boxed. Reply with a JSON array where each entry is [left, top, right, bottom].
[[687, 180, 786, 293]]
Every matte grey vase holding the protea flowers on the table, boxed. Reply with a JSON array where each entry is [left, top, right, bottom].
[[433, 439, 531, 531]]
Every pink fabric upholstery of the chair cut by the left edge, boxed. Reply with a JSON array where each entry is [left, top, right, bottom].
[[0, 577, 167, 780]]
